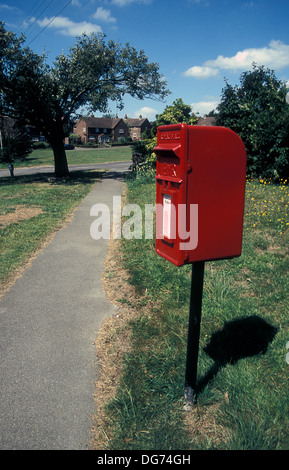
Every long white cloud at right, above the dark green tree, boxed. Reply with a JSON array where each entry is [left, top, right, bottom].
[[184, 40, 289, 78]]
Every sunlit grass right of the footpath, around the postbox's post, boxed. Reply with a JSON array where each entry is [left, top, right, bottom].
[[100, 173, 289, 450]]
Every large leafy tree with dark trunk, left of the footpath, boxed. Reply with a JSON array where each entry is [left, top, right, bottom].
[[0, 22, 169, 177]]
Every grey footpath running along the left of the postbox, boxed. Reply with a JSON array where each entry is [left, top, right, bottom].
[[0, 167, 123, 450]]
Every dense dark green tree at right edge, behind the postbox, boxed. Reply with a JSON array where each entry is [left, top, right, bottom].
[[216, 64, 289, 178]]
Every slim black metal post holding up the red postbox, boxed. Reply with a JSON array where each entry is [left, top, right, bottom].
[[184, 261, 205, 411]]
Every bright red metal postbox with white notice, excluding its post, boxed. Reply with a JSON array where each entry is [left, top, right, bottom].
[[154, 124, 246, 266]]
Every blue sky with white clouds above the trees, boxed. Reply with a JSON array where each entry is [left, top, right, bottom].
[[0, 0, 289, 120]]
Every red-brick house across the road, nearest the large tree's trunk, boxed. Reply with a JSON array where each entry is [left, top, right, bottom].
[[73, 117, 129, 144]]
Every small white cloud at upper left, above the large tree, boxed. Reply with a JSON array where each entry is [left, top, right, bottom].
[[37, 16, 101, 36]]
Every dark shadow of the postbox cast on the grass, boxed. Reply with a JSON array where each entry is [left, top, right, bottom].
[[196, 315, 277, 395]]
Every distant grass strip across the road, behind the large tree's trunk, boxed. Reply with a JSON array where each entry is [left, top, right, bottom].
[[0, 146, 131, 168]]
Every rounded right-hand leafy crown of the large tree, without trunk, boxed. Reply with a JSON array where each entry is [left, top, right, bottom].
[[52, 34, 169, 115]]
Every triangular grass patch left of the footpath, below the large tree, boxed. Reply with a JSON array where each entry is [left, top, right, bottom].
[[0, 171, 102, 294]]
